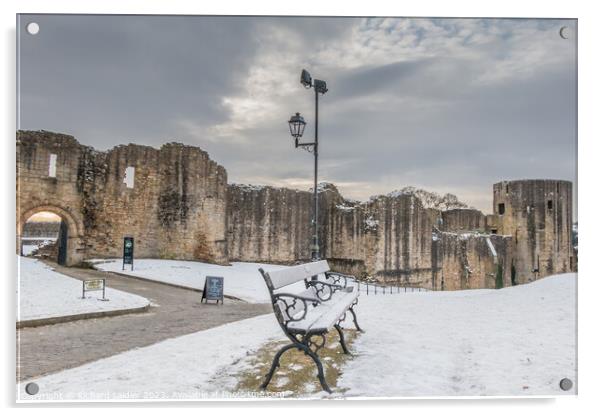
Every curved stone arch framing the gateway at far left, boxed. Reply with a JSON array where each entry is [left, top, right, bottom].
[[17, 205, 84, 266]]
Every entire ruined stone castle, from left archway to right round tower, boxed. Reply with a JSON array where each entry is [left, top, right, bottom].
[[17, 131, 576, 290]]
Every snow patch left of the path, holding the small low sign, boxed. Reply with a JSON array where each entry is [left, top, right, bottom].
[[17, 256, 149, 321]]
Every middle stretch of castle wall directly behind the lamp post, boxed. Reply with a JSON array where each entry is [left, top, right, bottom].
[[223, 185, 434, 285]]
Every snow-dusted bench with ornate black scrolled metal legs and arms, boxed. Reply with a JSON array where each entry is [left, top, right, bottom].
[[259, 260, 361, 393]]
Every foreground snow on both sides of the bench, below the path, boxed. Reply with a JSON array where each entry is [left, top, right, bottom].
[[18, 274, 577, 400]]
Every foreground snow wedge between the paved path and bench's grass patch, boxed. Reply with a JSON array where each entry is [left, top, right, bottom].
[[17, 314, 284, 400]]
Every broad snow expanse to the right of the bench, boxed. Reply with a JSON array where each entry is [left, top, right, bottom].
[[338, 274, 577, 397]]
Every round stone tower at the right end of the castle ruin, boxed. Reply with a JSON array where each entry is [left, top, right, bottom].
[[491, 180, 575, 284]]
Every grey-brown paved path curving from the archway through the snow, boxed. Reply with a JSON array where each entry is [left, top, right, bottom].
[[17, 264, 271, 381]]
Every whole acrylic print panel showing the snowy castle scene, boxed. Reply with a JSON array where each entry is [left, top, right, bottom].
[[16, 14, 577, 401]]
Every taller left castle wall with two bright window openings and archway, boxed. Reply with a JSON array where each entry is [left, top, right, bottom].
[[17, 131, 227, 264]]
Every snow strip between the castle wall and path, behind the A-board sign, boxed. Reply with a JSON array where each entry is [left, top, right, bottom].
[[91, 259, 303, 303]]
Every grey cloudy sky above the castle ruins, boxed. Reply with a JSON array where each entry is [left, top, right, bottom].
[[18, 15, 577, 212]]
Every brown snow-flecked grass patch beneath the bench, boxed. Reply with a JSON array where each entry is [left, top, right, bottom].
[[236, 329, 358, 397]]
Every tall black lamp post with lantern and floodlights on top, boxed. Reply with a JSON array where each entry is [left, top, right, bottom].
[[288, 69, 328, 261]]
